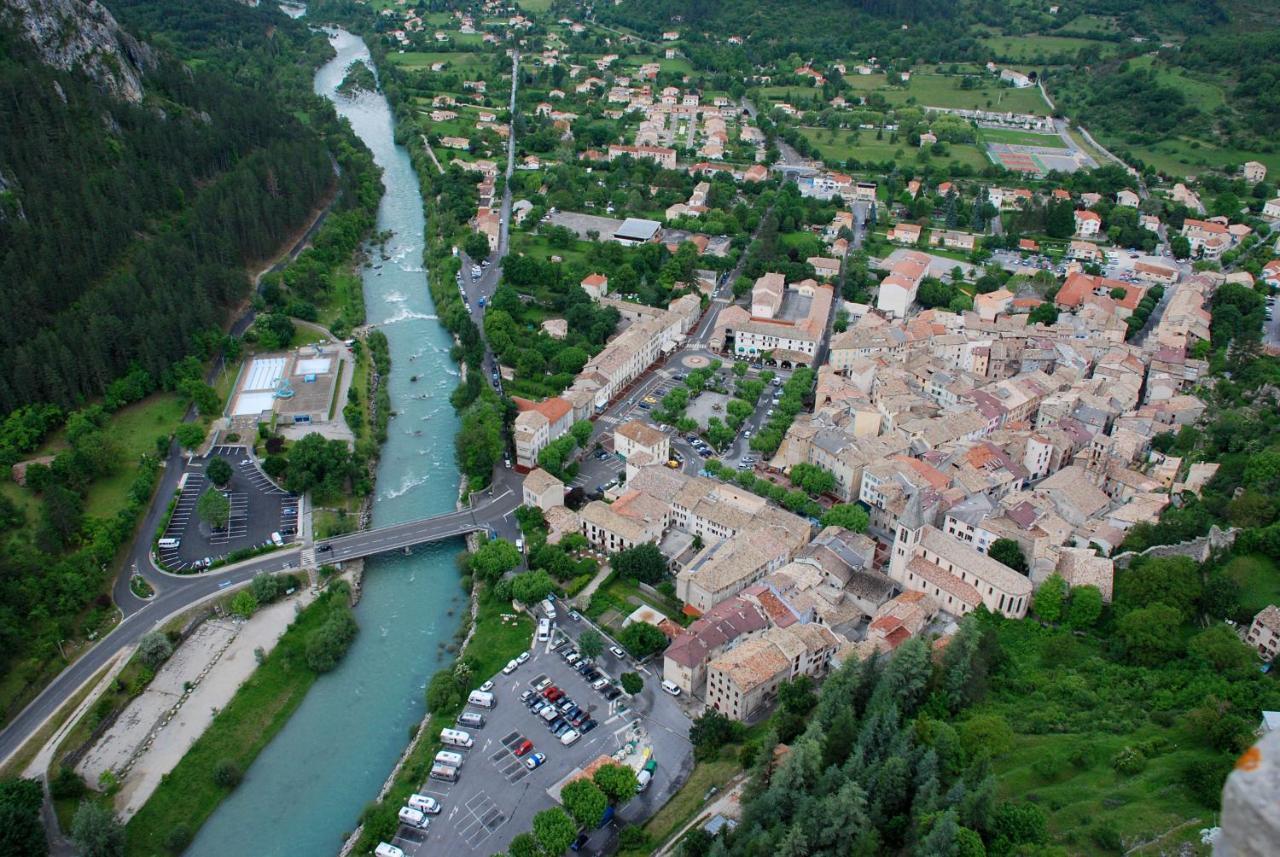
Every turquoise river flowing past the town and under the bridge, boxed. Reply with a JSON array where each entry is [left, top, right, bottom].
[[186, 25, 467, 857]]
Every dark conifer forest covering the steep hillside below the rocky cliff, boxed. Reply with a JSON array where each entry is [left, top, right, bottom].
[[0, 0, 340, 412]]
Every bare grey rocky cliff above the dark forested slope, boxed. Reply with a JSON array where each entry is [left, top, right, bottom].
[[0, 0, 156, 104]]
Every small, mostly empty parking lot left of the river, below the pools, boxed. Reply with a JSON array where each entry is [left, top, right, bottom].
[[159, 446, 301, 572]]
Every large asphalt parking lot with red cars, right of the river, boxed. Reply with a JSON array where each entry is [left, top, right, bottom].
[[392, 605, 692, 856]]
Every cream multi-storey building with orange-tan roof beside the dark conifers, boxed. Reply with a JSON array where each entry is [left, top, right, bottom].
[[707, 623, 841, 723]]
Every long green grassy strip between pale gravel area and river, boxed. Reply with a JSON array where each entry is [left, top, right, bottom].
[[125, 590, 347, 857]]
